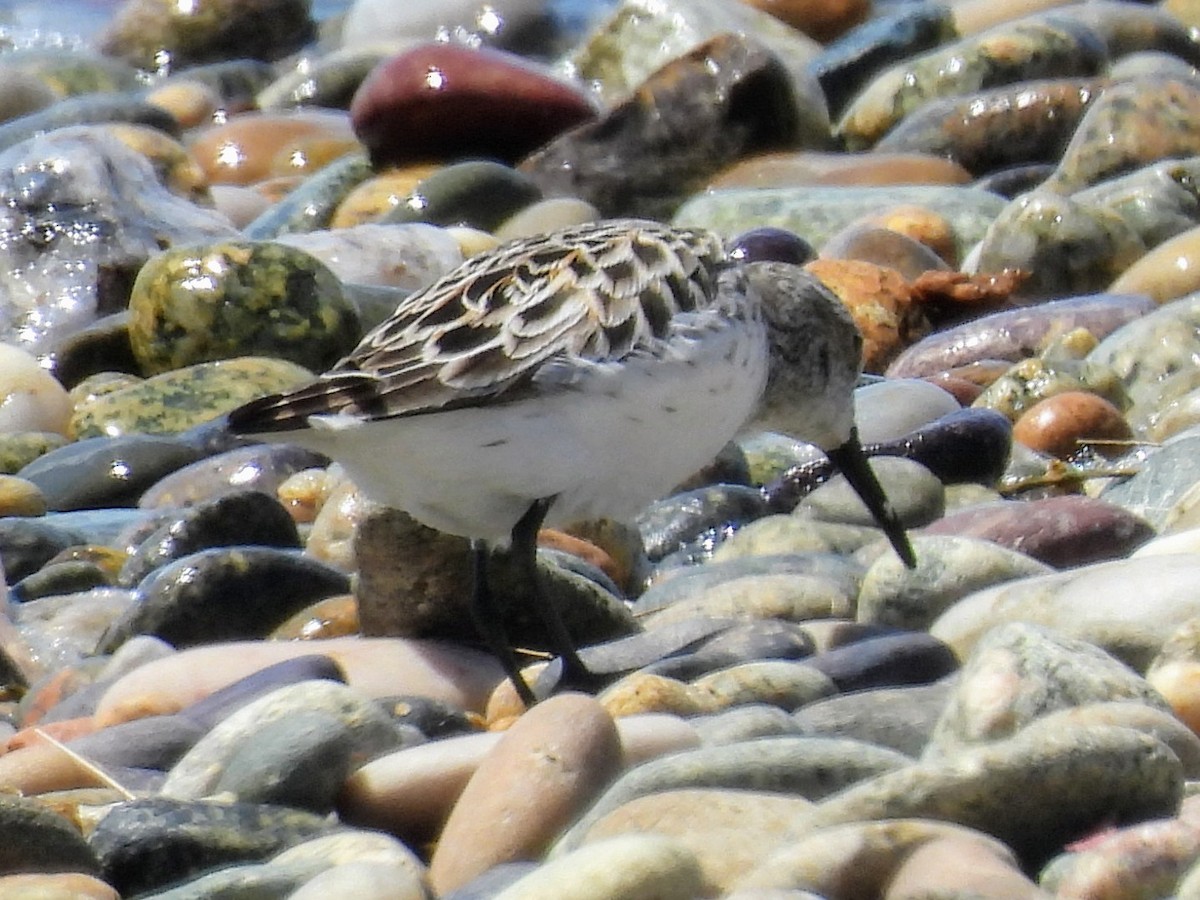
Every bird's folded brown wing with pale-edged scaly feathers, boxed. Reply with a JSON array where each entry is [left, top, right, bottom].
[[229, 220, 725, 433]]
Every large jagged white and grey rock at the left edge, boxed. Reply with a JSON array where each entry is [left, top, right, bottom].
[[0, 127, 233, 350]]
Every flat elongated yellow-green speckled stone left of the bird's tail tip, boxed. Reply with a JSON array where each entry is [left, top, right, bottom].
[[72, 356, 312, 438]]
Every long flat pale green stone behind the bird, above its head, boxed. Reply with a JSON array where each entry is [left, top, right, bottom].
[[672, 185, 1004, 264]]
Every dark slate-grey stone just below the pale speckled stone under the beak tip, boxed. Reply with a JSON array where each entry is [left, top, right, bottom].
[[793, 631, 959, 708]]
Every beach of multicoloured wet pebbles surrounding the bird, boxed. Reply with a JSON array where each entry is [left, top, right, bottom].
[[0, 0, 1200, 900]]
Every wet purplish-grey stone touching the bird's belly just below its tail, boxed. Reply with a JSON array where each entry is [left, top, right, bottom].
[[138, 444, 325, 509]]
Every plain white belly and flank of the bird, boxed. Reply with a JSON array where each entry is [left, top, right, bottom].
[[288, 322, 767, 541]]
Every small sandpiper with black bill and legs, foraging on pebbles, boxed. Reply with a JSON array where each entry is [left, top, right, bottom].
[[228, 220, 912, 703]]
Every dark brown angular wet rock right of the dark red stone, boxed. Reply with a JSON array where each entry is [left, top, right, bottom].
[[521, 34, 806, 220]]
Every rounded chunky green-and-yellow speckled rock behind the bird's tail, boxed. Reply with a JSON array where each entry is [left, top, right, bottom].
[[130, 241, 361, 374]]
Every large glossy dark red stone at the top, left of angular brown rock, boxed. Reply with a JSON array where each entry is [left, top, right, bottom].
[[350, 43, 596, 166]]
